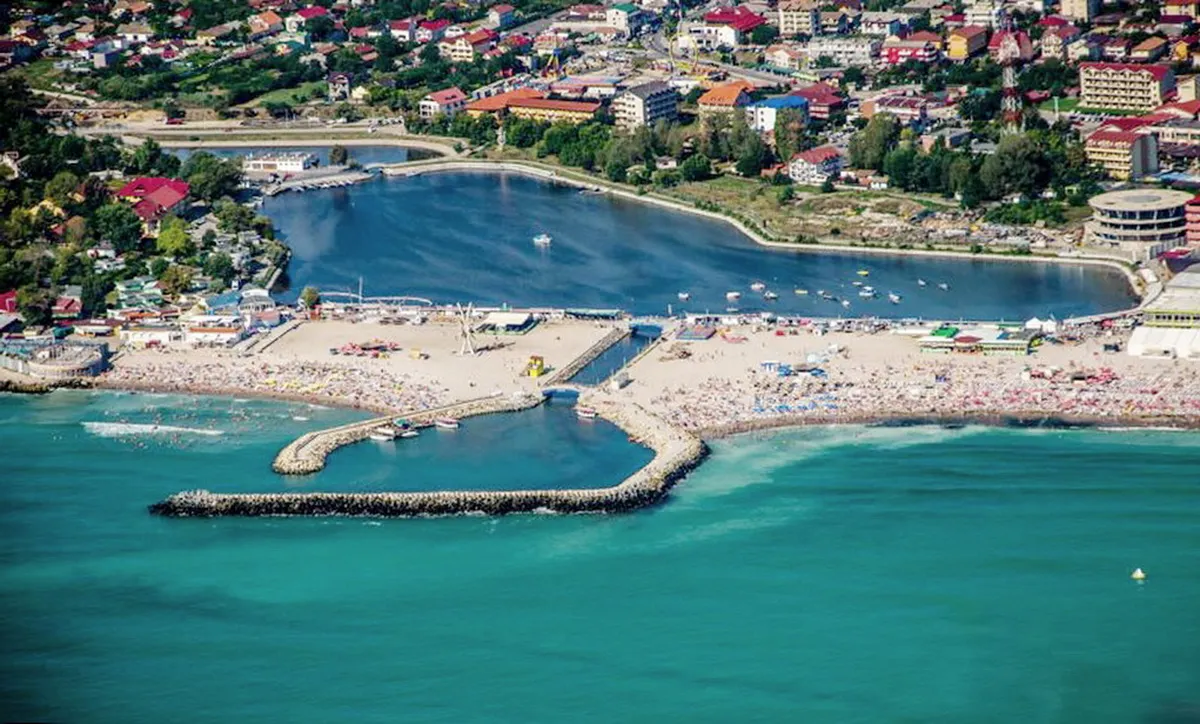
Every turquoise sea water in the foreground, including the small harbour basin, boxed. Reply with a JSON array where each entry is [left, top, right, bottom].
[[0, 393, 1200, 723]]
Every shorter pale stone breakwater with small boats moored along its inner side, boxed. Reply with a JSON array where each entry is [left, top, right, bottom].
[[271, 395, 542, 475]]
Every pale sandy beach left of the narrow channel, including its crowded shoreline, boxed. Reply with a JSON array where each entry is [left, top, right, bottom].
[[96, 321, 611, 413]]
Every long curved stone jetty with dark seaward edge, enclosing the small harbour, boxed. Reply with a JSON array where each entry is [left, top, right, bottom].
[[150, 400, 708, 517]]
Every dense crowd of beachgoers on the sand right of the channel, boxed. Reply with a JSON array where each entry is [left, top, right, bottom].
[[650, 336, 1200, 431]]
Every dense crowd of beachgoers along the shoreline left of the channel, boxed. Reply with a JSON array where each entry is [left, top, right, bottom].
[[101, 358, 448, 413]]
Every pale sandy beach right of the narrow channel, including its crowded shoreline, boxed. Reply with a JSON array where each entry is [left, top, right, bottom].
[[595, 328, 1200, 438]]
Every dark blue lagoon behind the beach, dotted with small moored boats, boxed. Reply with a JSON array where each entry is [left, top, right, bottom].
[[265, 173, 1134, 319]]
